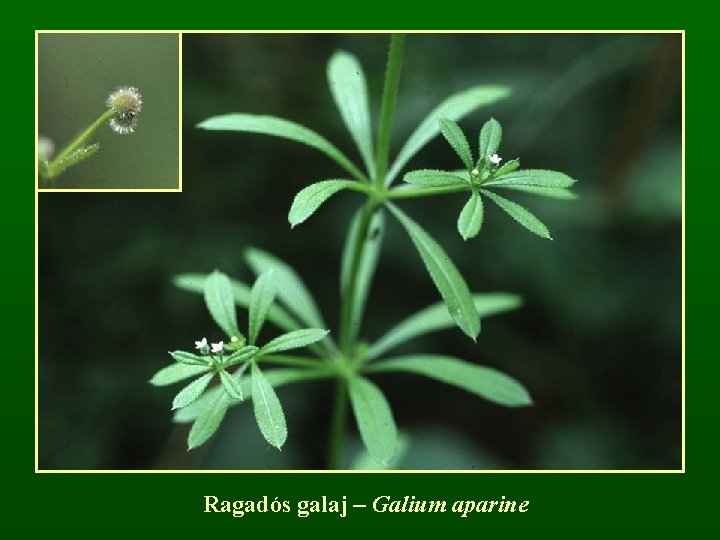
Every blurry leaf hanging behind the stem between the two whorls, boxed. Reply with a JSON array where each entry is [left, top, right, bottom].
[[340, 208, 385, 338]]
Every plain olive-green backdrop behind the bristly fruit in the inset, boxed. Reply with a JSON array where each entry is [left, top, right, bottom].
[[38, 33, 180, 189]]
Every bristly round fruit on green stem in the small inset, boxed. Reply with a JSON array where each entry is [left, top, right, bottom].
[[38, 86, 142, 187]]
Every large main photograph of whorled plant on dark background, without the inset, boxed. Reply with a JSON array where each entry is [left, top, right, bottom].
[[39, 34, 682, 470]]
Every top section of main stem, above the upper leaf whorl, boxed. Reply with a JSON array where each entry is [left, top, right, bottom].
[[375, 34, 405, 187]]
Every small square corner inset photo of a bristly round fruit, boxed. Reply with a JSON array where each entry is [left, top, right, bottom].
[[36, 31, 182, 191]]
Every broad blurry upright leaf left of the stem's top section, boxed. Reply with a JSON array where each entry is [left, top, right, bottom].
[[327, 51, 375, 174]]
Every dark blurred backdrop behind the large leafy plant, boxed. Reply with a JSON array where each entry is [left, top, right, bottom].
[[39, 34, 682, 469]]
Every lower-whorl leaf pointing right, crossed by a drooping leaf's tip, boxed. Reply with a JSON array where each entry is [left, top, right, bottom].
[[367, 292, 522, 359]]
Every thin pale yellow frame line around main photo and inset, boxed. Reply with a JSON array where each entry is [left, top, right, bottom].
[[35, 30, 685, 474]]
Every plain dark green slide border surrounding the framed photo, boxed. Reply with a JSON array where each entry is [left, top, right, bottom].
[[23, 2, 696, 535]]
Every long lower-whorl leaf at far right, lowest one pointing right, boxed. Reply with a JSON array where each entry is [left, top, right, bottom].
[[372, 354, 532, 407]]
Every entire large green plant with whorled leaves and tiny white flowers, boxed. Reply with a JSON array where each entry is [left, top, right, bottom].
[[151, 35, 574, 469]]
